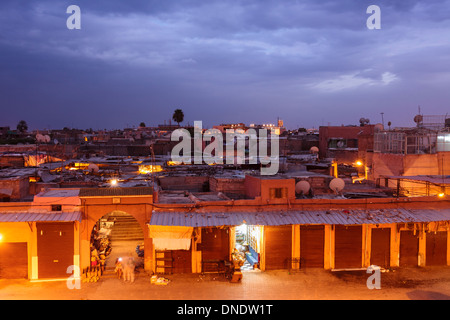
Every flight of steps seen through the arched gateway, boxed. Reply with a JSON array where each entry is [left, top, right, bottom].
[[108, 212, 144, 242]]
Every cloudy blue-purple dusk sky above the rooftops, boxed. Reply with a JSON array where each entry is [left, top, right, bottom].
[[0, 0, 450, 129]]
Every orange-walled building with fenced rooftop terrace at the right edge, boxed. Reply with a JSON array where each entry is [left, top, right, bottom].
[[371, 122, 450, 196]]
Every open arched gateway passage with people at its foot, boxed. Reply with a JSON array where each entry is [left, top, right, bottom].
[[90, 211, 144, 271]]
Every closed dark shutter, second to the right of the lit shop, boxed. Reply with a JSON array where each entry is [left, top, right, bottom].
[[300, 226, 325, 268]]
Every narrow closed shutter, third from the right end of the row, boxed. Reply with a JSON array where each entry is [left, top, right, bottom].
[[370, 228, 391, 268]]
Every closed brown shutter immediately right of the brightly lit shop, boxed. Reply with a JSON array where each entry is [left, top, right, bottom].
[[264, 226, 292, 270]]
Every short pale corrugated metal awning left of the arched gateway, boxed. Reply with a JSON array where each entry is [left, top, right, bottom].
[[0, 211, 81, 222]]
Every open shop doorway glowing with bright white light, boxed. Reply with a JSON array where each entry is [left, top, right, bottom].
[[234, 223, 263, 271]]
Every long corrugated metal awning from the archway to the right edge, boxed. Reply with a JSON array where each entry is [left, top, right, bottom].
[[150, 209, 450, 227]]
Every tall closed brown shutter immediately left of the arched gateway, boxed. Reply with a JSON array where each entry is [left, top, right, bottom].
[[36, 223, 74, 278]]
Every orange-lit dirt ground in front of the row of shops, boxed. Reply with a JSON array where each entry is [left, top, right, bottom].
[[0, 267, 450, 300]]
